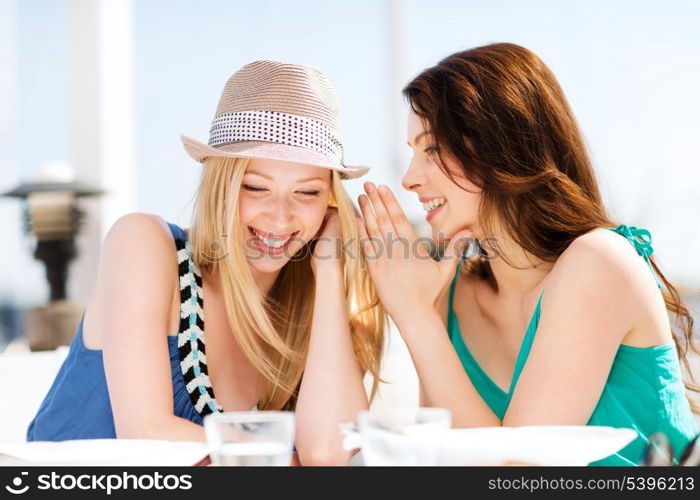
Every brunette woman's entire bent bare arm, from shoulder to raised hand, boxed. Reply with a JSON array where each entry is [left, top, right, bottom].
[[359, 183, 652, 427]]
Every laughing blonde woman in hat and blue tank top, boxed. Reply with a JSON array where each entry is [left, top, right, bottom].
[[27, 61, 384, 464]]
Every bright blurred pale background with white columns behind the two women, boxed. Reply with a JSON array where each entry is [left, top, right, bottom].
[[0, 0, 700, 422]]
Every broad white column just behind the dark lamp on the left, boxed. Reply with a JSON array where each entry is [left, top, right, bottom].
[[69, 0, 135, 305]]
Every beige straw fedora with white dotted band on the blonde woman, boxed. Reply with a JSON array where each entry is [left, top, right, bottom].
[[181, 61, 369, 179]]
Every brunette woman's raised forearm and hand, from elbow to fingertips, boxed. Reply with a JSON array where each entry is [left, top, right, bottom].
[[358, 183, 499, 427]]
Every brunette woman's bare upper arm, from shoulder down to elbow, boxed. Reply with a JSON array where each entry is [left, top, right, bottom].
[[503, 231, 648, 426]]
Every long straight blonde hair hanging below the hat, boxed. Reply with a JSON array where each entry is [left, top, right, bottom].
[[189, 157, 387, 410]]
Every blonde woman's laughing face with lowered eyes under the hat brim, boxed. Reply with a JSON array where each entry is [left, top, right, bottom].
[[238, 159, 331, 273]]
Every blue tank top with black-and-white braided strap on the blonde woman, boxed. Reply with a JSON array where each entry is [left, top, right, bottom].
[[27, 224, 221, 441]]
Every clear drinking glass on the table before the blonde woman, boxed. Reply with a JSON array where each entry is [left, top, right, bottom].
[[204, 411, 294, 466]]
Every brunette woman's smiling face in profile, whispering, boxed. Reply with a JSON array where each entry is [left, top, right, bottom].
[[401, 109, 481, 242]]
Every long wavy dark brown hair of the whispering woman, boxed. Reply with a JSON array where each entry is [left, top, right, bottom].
[[403, 43, 700, 413]]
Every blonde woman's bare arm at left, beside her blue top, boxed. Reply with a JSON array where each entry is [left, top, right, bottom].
[[95, 214, 204, 441]]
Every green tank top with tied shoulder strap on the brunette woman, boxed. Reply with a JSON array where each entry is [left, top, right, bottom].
[[447, 225, 698, 465]]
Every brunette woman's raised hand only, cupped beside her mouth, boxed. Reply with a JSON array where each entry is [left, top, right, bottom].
[[358, 182, 471, 329]]
